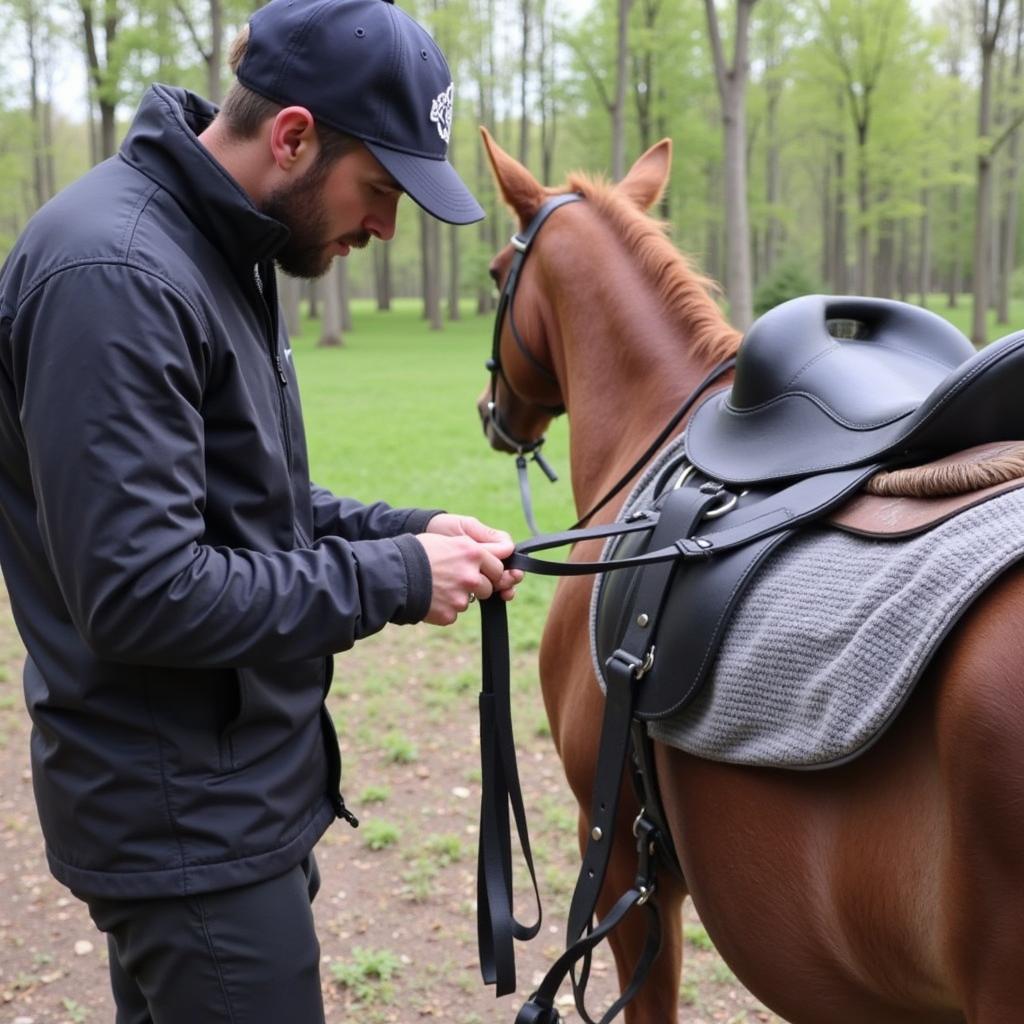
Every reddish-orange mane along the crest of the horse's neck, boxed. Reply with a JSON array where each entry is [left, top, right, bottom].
[[559, 171, 740, 364]]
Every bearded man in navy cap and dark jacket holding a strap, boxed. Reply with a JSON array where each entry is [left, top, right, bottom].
[[0, 0, 519, 1024]]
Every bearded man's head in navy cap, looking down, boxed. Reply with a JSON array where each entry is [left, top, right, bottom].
[[218, 0, 483, 275]]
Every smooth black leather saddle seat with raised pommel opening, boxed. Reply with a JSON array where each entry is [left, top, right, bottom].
[[686, 295, 1024, 484]]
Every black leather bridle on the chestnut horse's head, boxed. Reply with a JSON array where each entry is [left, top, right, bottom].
[[486, 193, 583, 536]]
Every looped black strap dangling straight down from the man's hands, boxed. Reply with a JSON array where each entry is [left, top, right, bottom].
[[476, 594, 542, 995]]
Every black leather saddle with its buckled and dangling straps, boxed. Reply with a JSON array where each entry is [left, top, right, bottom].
[[479, 284, 1024, 1024]]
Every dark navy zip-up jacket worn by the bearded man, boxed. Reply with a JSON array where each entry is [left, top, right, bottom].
[[0, 86, 433, 897]]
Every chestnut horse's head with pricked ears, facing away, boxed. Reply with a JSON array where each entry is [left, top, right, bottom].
[[477, 129, 672, 454]]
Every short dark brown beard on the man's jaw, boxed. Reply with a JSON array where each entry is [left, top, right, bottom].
[[260, 161, 370, 280]]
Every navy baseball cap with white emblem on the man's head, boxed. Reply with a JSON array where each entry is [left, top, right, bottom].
[[238, 0, 483, 224]]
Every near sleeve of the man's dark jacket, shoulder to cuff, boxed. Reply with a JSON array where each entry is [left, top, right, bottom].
[[12, 263, 430, 667]]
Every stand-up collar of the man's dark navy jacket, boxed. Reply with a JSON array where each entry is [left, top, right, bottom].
[[120, 85, 288, 266]]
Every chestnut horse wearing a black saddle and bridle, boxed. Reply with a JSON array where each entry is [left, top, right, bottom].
[[481, 133, 1024, 1024]]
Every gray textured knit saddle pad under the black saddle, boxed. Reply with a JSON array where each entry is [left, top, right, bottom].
[[591, 445, 1024, 769]]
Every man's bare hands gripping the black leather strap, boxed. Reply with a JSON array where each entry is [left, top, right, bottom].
[[418, 512, 522, 626]]
